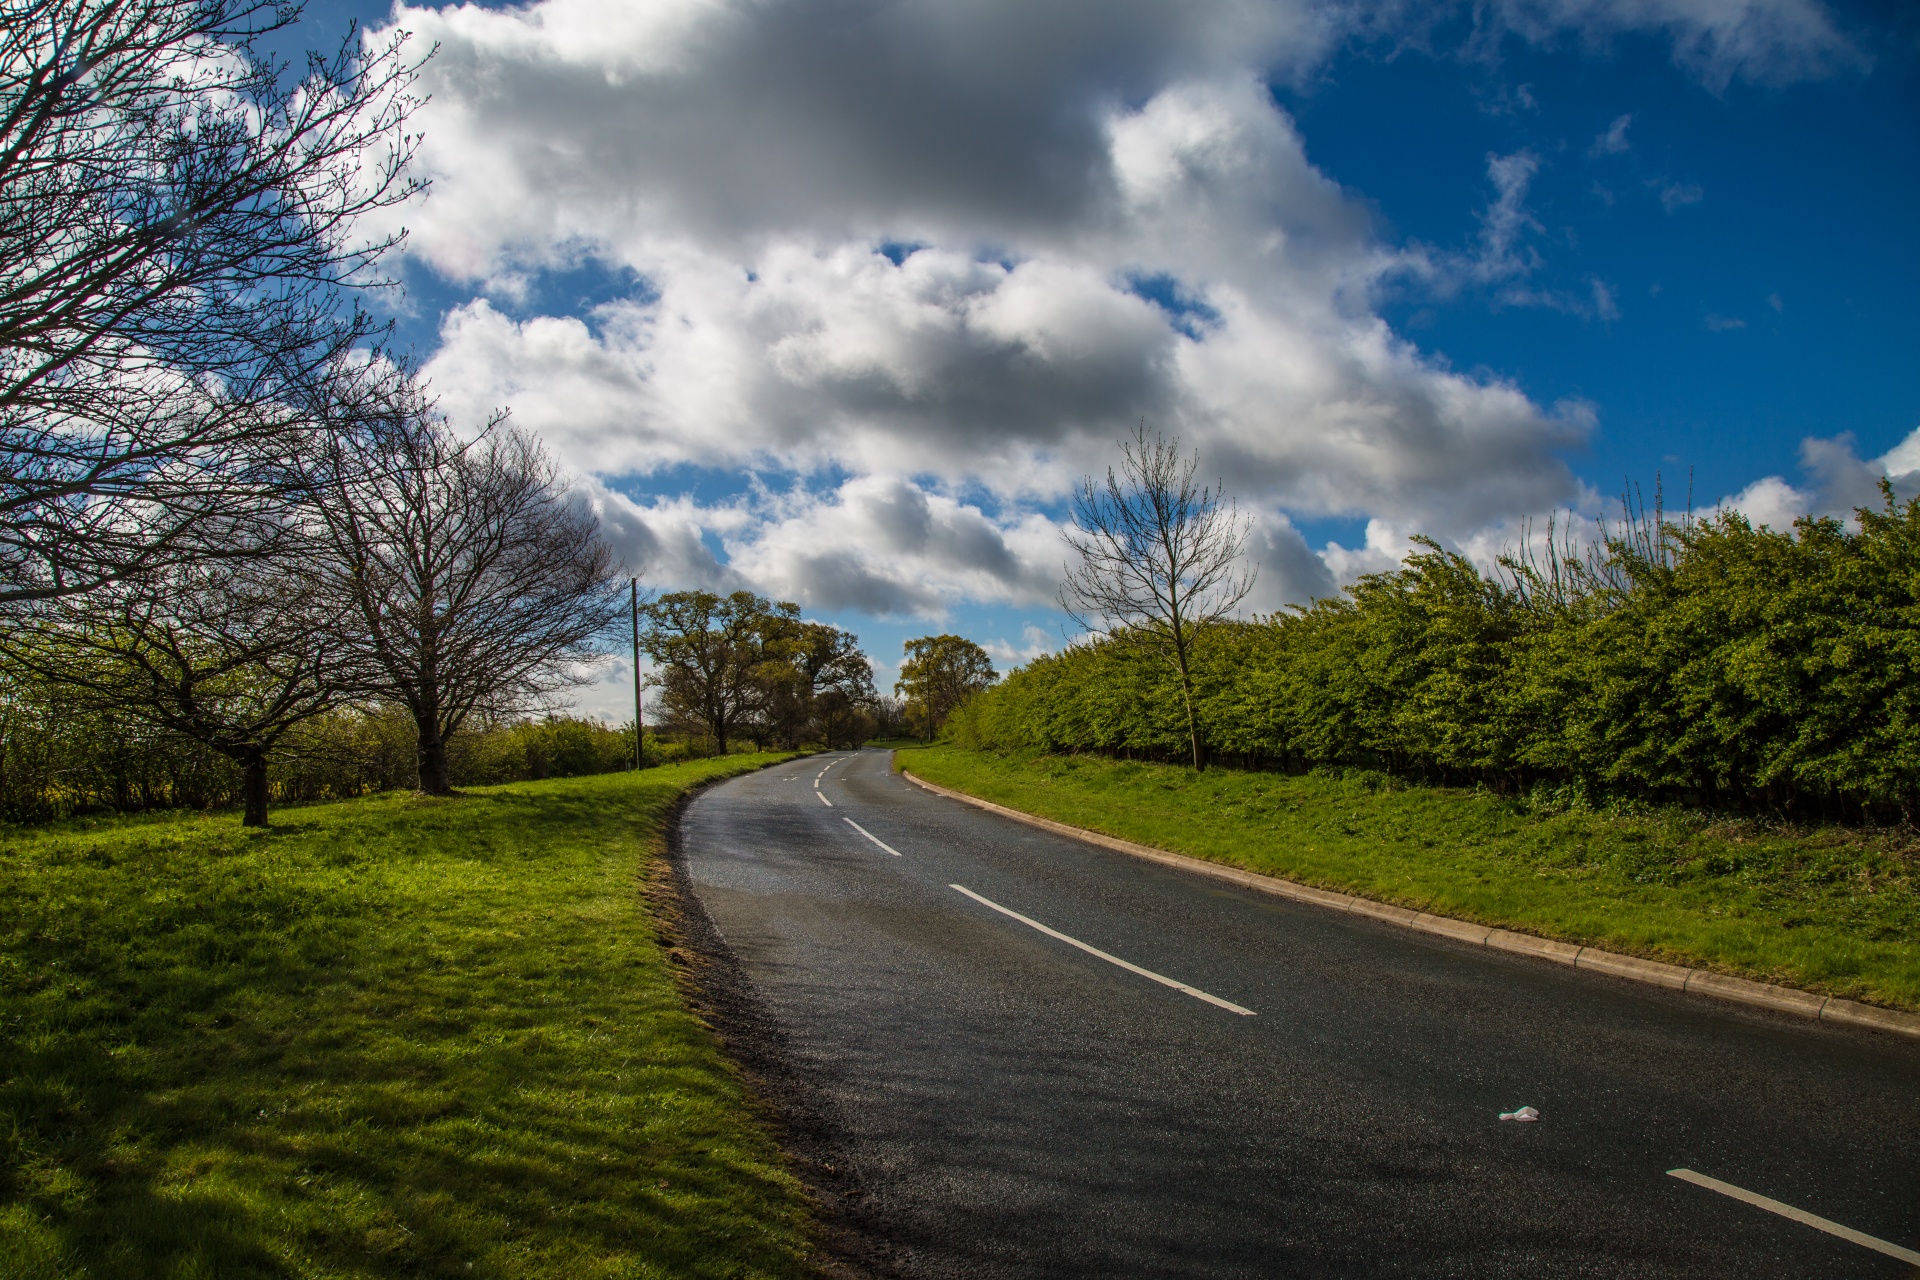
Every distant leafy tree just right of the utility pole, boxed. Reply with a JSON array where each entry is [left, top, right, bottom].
[[639, 591, 801, 754]]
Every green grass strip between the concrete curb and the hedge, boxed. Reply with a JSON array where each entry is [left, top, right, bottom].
[[897, 747, 1920, 1009]]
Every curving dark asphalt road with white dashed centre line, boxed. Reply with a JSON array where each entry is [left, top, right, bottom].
[[682, 752, 1920, 1280]]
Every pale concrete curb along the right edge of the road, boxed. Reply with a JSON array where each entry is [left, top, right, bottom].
[[900, 770, 1920, 1038]]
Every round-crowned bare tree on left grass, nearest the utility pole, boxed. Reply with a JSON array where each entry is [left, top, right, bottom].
[[313, 370, 624, 794]]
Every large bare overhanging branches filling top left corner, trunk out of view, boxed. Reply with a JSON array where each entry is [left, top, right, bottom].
[[0, 0, 417, 606]]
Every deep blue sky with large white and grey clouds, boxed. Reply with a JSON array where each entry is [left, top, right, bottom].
[[288, 0, 1920, 714]]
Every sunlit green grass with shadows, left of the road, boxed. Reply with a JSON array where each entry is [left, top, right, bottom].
[[0, 756, 812, 1280]]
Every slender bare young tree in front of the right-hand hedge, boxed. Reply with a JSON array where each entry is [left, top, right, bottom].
[[1060, 424, 1254, 770]]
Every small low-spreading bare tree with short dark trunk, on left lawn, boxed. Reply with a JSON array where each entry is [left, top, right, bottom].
[[0, 525, 357, 827]]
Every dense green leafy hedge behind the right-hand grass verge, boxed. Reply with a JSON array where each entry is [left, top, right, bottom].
[[948, 493, 1920, 819]]
